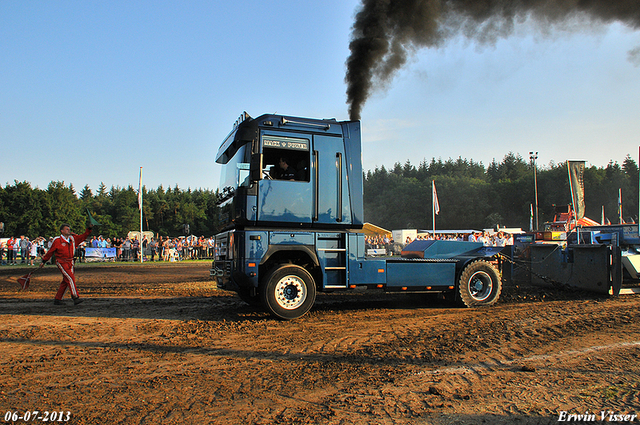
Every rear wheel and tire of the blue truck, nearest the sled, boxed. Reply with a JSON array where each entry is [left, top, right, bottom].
[[458, 261, 502, 307]]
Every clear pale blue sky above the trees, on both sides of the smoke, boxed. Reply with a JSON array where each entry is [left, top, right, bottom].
[[0, 0, 640, 191]]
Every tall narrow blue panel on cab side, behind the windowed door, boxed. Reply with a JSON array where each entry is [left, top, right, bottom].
[[311, 135, 350, 225]]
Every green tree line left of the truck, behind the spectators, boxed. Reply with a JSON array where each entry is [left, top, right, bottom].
[[0, 181, 218, 238]]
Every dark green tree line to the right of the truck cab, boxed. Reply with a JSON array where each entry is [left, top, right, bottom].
[[364, 152, 638, 230]]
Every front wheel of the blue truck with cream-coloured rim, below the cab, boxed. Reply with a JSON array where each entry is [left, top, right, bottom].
[[260, 264, 316, 320]]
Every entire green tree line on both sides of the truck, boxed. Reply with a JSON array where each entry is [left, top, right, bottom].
[[0, 152, 638, 238]]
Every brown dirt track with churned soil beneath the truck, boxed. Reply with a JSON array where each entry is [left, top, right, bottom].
[[0, 263, 640, 424]]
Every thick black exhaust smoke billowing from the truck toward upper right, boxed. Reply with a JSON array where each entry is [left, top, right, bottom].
[[345, 0, 640, 120]]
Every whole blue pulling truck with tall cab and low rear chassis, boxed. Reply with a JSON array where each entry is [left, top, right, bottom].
[[210, 112, 502, 320]]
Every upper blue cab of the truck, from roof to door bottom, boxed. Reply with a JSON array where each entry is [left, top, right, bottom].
[[216, 113, 363, 229]]
